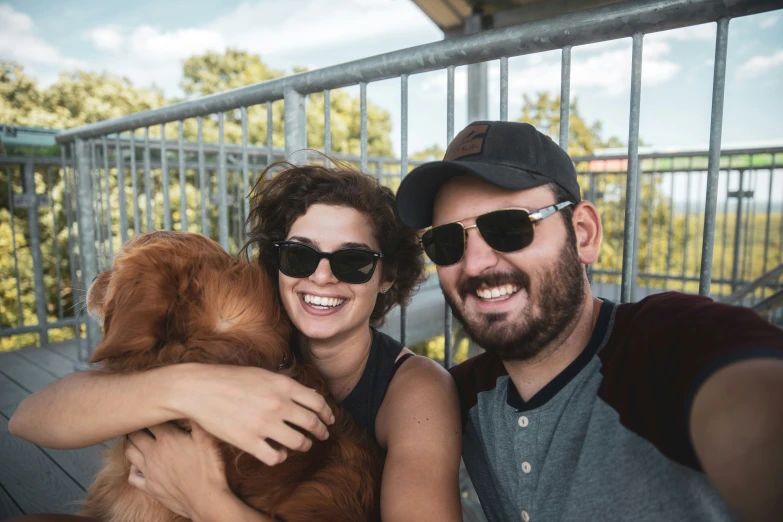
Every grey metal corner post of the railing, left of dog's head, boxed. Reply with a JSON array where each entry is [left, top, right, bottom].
[[75, 138, 101, 367]]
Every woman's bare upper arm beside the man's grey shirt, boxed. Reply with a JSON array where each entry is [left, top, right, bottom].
[[376, 357, 462, 522]]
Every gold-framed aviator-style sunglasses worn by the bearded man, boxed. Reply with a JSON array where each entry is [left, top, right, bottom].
[[421, 201, 573, 266]]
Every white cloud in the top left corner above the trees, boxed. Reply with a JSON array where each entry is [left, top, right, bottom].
[[0, 4, 84, 69]]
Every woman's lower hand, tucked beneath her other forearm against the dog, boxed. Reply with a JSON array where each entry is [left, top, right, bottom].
[[125, 423, 234, 519]]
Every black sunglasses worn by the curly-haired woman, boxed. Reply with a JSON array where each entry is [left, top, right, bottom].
[[273, 241, 383, 285]]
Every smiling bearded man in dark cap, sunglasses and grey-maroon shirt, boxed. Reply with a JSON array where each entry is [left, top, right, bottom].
[[397, 122, 783, 522]]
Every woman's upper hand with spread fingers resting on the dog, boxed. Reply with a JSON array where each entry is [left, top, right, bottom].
[[174, 364, 334, 466]]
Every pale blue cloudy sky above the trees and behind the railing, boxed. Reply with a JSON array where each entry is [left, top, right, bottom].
[[0, 0, 783, 153]]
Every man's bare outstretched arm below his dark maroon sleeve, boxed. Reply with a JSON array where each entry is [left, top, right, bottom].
[[689, 358, 783, 522]]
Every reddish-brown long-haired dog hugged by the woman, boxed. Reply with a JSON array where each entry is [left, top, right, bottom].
[[81, 232, 382, 522]]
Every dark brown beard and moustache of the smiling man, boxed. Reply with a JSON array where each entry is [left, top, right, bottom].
[[441, 241, 585, 360]]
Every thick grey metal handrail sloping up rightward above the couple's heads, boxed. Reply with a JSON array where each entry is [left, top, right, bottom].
[[56, 0, 780, 143]]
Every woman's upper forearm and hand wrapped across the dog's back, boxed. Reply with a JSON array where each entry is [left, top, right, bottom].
[[9, 364, 334, 465]]
